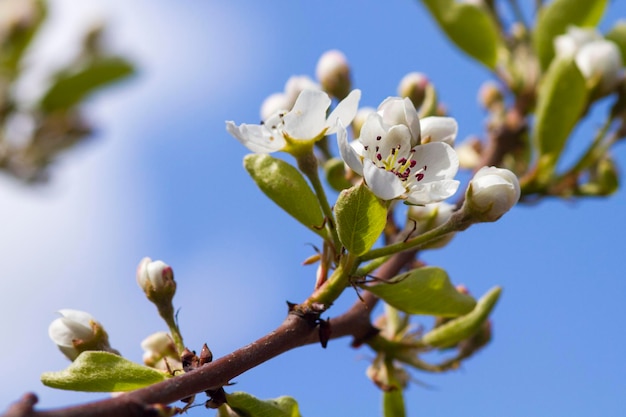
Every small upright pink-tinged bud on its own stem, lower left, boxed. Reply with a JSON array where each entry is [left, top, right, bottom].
[[137, 257, 176, 304]]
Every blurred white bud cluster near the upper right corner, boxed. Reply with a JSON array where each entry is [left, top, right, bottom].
[[554, 26, 624, 93]]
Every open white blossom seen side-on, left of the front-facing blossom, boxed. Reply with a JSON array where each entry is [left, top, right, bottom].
[[226, 90, 361, 153]]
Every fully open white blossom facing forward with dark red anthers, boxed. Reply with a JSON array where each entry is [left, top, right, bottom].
[[337, 107, 459, 205]]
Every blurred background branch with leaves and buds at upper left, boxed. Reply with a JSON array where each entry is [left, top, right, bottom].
[[0, 0, 134, 183]]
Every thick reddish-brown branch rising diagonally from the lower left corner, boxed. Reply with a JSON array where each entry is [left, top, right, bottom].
[[2, 251, 415, 417]]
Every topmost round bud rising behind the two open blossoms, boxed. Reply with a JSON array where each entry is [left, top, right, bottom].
[[315, 49, 352, 100]]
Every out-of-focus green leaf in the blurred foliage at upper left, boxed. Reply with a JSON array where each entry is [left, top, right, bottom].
[[40, 57, 134, 112]]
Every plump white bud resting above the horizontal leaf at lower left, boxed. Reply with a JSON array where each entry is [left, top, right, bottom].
[[48, 309, 119, 361]]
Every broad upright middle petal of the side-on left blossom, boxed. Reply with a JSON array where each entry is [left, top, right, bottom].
[[283, 90, 330, 140]]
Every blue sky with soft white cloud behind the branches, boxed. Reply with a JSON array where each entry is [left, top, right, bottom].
[[0, 0, 626, 417]]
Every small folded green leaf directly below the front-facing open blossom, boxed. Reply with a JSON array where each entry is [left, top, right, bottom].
[[335, 183, 387, 256]]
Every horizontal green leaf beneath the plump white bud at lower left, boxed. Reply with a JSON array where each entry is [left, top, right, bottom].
[[41, 351, 169, 392]]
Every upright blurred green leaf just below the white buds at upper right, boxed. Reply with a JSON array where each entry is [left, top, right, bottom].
[[533, 58, 589, 178]]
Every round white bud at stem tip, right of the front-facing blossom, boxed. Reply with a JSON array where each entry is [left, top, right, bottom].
[[463, 167, 521, 222]]
